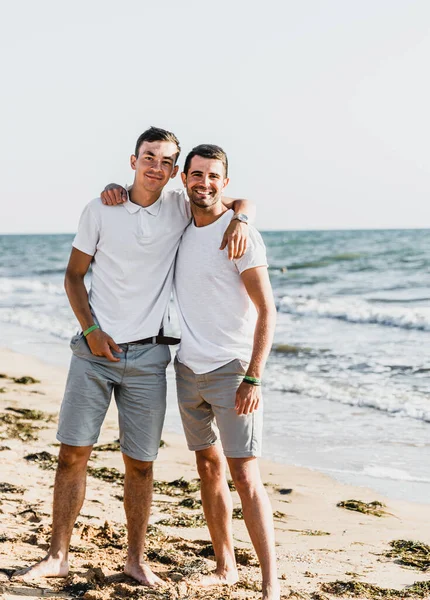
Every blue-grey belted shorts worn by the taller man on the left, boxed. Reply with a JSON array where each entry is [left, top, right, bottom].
[[57, 334, 170, 461]]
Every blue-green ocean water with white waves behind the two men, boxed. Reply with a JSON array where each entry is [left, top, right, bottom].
[[0, 230, 430, 502]]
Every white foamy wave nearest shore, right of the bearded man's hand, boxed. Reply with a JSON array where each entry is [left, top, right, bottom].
[[267, 365, 430, 423]]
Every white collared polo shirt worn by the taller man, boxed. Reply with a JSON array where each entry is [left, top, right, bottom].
[[73, 190, 191, 344]]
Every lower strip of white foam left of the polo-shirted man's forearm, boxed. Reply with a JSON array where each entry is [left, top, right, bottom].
[[0, 309, 74, 340]]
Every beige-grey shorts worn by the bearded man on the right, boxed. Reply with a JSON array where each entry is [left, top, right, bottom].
[[175, 359, 263, 458]]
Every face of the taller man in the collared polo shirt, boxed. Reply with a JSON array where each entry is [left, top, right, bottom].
[[130, 142, 178, 193]]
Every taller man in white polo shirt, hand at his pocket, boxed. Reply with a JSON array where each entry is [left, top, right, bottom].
[[16, 128, 249, 587]]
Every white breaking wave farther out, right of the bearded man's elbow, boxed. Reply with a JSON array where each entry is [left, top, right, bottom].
[[278, 296, 430, 331]]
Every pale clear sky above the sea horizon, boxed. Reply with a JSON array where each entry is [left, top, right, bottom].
[[0, 0, 430, 233]]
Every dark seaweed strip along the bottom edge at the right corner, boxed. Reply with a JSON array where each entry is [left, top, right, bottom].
[[321, 580, 430, 600]]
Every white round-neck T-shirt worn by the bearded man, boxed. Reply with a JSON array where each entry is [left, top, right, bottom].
[[174, 210, 267, 374]]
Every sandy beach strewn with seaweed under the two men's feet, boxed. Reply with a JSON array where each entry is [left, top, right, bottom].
[[0, 350, 430, 600]]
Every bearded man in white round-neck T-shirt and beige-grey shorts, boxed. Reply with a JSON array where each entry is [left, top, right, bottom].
[[174, 145, 280, 600]]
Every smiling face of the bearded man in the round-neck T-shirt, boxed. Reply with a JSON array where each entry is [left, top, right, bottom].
[[182, 156, 229, 208]]
